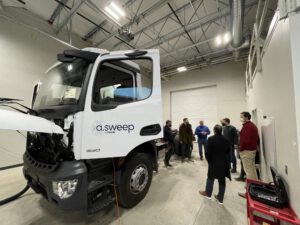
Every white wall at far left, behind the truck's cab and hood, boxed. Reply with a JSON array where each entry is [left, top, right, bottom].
[[0, 12, 86, 168]]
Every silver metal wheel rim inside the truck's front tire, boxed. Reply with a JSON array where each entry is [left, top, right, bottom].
[[130, 164, 149, 194]]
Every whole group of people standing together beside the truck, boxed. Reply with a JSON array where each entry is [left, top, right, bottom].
[[164, 112, 259, 204]]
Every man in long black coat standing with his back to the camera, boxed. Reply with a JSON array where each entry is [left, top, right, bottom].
[[199, 125, 231, 205]]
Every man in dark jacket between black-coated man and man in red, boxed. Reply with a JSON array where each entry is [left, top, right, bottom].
[[221, 118, 238, 173]]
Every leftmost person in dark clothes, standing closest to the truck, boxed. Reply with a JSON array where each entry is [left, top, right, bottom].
[[164, 120, 175, 167]]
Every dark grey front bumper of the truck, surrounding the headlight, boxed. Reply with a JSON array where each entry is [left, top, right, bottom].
[[23, 152, 88, 210]]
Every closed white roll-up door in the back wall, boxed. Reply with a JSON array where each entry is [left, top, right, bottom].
[[171, 86, 220, 135]]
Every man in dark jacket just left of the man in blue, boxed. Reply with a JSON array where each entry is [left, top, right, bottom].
[[179, 118, 194, 162]]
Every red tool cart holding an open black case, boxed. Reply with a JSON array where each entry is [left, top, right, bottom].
[[247, 168, 300, 225]]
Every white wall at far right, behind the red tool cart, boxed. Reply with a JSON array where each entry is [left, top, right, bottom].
[[247, 12, 300, 216]]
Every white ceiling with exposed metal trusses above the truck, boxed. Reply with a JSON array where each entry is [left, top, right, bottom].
[[3, 0, 277, 74]]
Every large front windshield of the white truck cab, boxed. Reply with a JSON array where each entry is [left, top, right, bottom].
[[34, 59, 89, 108]]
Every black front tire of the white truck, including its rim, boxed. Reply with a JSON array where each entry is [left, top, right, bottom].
[[118, 153, 153, 208]]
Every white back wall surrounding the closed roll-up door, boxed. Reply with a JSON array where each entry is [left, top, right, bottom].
[[162, 62, 247, 129]]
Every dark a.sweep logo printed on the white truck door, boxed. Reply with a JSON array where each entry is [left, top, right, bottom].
[[94, 123, 134, 134]]
